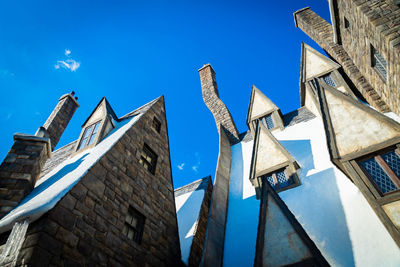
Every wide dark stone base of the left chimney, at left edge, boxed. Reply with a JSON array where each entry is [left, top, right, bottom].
[[0, 134, 51, 218]]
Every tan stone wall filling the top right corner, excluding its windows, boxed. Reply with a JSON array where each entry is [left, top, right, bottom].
[[337, 0, 400, 114]]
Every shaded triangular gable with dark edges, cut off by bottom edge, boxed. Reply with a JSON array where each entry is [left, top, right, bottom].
[[254, 182, 329, 266]]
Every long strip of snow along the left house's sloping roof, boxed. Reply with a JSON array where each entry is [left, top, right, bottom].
[[0, 113, 143, 233]]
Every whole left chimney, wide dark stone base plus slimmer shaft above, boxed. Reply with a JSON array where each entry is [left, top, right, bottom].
[[0, 93, 79, 219]]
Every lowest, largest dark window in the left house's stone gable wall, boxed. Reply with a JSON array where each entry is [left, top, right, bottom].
[[122, 207, 146, 244]]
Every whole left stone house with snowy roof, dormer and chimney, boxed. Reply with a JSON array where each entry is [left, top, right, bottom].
[[0, 94, 180, 266]]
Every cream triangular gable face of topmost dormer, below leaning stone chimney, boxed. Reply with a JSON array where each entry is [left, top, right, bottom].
[[300, 43, 340, 82]]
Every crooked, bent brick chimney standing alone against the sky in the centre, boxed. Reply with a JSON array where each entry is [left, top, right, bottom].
[[199, 64, 239, 145]]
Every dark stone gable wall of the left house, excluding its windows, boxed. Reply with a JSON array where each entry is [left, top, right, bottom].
[[18, 98, 181, 266]]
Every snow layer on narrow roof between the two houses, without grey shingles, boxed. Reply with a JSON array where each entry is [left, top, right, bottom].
[[175, 189, 205, 264]]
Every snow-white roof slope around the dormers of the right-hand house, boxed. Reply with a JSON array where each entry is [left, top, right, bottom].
[[224, 118, 400, 266]]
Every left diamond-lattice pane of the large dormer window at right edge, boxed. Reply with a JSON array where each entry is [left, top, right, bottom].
[[361, 158, 397, 193]]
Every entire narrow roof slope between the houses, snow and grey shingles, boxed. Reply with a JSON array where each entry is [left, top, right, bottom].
[[175, 176, 211, 264]]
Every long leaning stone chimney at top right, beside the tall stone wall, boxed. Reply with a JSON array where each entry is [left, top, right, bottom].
[[294, 8, 395, 112]]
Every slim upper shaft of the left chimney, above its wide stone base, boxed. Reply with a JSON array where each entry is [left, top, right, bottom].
[[42, 91, 79, 151]]
